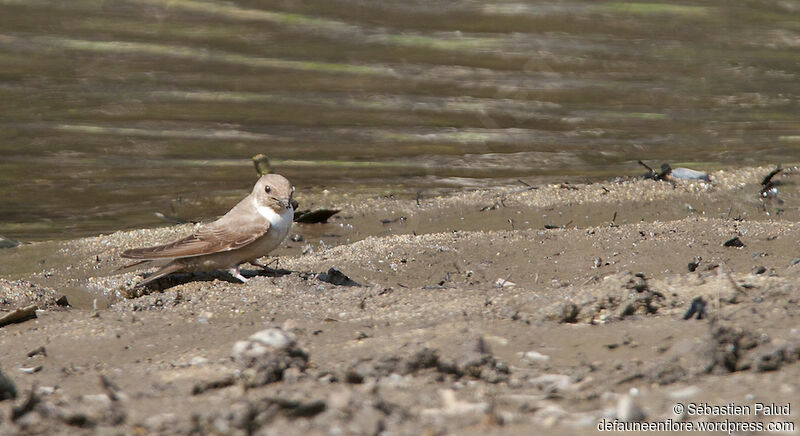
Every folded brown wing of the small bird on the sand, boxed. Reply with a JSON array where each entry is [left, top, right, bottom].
[[121, 221, 269, 259]]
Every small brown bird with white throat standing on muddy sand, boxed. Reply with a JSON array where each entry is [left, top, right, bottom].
[[122, 174, 294, 286]]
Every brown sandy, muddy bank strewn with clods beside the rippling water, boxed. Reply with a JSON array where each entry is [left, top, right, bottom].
[[0, 168, 800, 435]]
